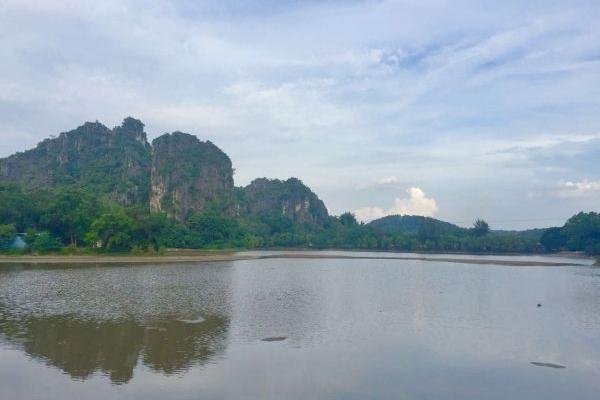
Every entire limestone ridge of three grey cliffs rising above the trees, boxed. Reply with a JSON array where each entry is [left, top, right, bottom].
[[0, 118, 328, 225]]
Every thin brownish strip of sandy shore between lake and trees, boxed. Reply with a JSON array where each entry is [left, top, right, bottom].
[[0, 251, 585, 267]]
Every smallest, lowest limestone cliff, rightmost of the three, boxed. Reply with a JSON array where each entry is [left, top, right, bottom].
[[239, 178, 329, 225]]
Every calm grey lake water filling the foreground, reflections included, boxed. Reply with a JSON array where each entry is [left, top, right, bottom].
[[0, 257, 600, 399]]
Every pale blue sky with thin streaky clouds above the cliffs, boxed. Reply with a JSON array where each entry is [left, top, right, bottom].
[[0, 0, 600, 229]]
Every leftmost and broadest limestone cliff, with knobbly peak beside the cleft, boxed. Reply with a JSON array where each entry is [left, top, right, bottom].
[[0, 118, 150, 205]]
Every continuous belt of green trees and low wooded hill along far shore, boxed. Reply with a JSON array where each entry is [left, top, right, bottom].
[[0, 184, 600, 254]]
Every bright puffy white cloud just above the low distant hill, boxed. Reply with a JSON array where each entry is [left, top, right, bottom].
[[354, 187, 438, 222]]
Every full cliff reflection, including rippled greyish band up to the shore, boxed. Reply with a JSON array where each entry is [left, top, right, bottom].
[[0, 263, 232, 384]]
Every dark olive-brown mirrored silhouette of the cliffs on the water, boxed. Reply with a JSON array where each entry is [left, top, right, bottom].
[[0, 306, 229, 383]]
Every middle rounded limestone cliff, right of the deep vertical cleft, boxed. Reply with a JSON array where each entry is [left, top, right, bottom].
[[150, 132, 233, 221]]
